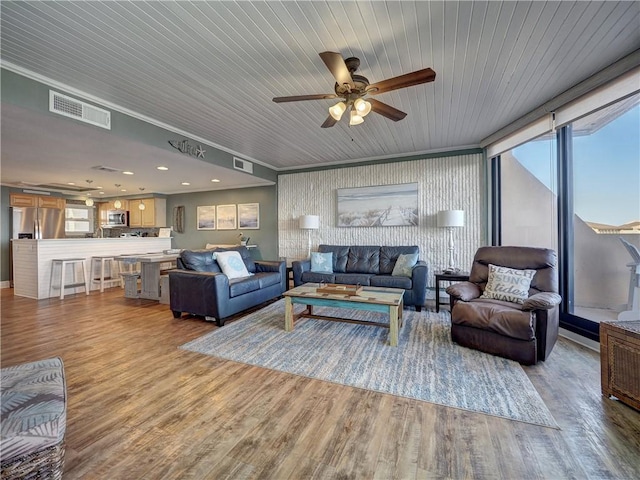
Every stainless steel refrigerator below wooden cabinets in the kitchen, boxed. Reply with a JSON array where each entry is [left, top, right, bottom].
[[11, 207, 64, 239]]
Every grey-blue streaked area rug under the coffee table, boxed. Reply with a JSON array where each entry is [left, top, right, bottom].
[[180, 300, 559, 428]]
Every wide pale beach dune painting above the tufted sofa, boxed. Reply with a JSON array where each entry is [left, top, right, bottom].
[[337, 183, 418, 227]]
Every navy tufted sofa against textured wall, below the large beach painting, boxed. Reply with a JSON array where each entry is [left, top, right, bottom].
[[291, 245, 429, 312]]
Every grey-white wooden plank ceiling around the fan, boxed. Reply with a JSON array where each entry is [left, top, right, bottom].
[[1, 1, 640, 190]]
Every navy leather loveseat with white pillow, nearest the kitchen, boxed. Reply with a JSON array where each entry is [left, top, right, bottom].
[[169, 247, 286, 327]]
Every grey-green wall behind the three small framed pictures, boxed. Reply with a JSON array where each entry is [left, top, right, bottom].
[[167, 185, 278, 260]]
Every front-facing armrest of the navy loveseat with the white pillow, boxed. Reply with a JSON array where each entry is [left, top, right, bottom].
[[168, 269, 229, 319]]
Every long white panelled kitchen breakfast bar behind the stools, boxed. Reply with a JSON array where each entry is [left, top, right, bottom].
[[11, 237, 171, 300]]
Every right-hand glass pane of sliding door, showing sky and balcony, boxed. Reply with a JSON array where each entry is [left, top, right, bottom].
[[568, 95, 640, 322]]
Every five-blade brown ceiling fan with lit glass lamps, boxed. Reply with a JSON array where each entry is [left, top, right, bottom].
[[273, 52, 436, 128]]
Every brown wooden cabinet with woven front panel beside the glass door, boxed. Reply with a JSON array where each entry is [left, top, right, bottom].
[[600, 320, 640, 410]]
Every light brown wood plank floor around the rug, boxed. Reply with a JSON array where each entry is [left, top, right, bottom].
[[1, 288, 640, 480]]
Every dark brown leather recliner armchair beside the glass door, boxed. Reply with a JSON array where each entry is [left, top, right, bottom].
[[447, 247, 562, 365]]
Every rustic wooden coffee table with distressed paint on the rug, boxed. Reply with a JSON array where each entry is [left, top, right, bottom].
[[283, 283, 404, 347]]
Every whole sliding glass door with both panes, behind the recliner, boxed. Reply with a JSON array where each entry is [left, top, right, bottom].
[[494, 94, 640, 339]]
